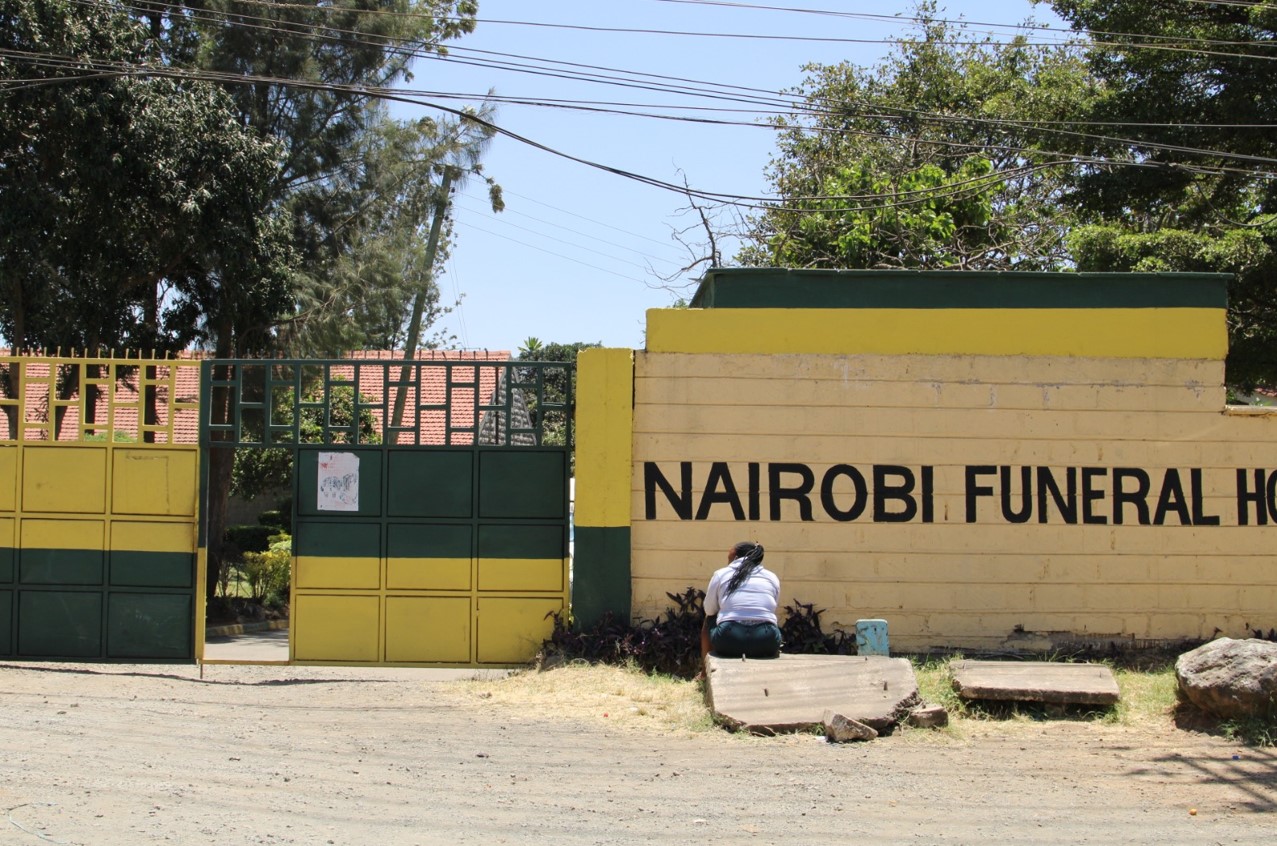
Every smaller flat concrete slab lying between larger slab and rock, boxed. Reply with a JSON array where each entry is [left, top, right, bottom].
[[950, 661, 1121, 705]]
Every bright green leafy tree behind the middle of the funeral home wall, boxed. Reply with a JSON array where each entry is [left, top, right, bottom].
[[738, 3, 1094, 270]]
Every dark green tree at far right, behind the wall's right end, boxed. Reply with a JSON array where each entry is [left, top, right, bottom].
[[1051, 0, 1277, 388]]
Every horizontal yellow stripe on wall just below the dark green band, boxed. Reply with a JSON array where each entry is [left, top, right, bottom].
[[648, 308, 1228, 360]]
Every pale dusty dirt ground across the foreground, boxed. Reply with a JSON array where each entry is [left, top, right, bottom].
[[0, 663, 1277, 846]]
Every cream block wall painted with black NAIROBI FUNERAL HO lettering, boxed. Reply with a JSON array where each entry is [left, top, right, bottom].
[[631, 347, 1277, 649]]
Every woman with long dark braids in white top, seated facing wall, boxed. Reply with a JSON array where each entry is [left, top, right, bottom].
[[701, 541, 780, 663]]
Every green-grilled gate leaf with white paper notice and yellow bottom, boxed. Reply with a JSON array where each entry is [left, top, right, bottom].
[[202, 358, 572, 666]]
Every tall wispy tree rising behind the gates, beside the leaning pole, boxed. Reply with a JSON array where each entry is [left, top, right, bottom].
[[135, 0, 485, 355]]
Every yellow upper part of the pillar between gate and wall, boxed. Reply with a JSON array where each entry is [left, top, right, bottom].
[[575, 349, 633, 527]]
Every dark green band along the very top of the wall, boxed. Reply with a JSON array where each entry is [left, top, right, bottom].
[[691, 267, 1232, 308]]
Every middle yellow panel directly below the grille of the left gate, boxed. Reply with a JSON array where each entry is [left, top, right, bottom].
[[22, 445, 106, 514]]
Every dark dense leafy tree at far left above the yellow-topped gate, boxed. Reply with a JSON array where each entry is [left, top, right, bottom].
[[0, 0, 294, 350]]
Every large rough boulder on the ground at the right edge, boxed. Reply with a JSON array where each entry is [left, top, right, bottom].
[[1175, 638, 1277, 719]]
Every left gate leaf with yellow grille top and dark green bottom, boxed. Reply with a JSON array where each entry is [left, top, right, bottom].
[[0, 355, 203, 661]]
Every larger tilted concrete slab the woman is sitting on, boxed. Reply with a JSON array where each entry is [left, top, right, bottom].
[[705, 654, 918, 734]]
